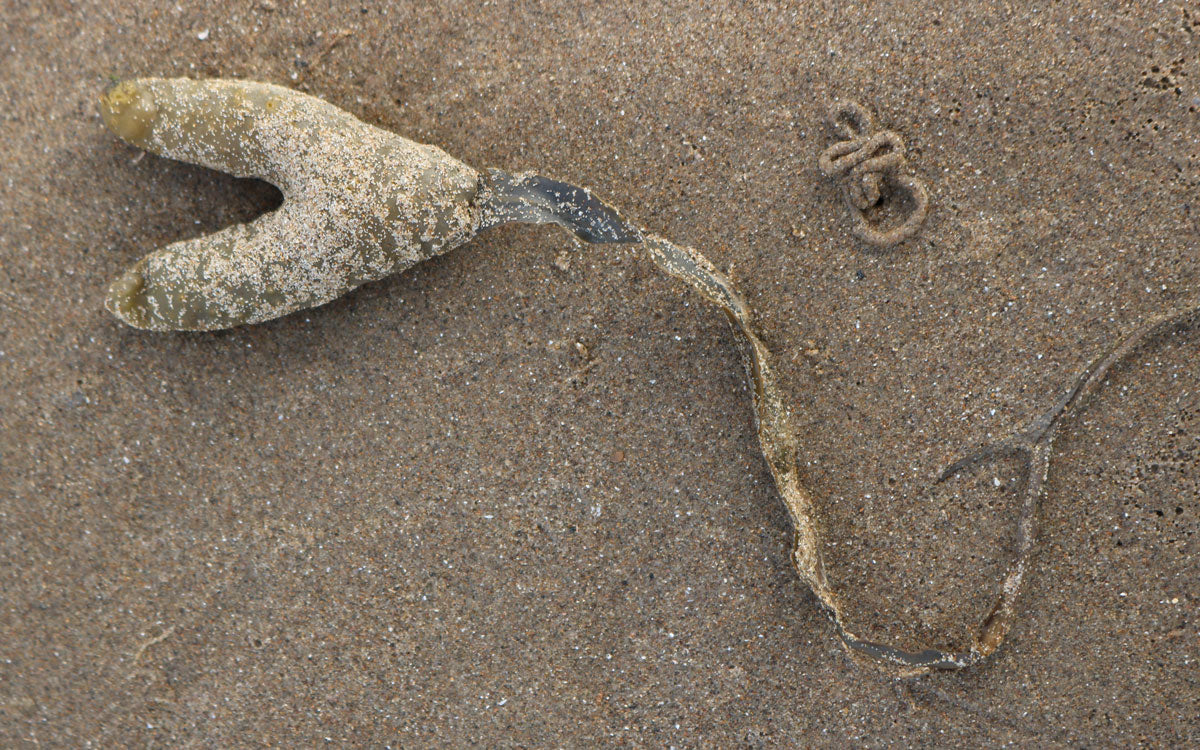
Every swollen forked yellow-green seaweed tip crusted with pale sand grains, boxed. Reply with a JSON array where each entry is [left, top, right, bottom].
[[100, 78, 480, 330]]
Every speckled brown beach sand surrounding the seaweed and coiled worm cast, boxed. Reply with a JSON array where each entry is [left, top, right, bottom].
[[0, 0, 1200, 748]]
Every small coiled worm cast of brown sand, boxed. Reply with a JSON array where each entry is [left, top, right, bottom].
[[817, 101, 929, 247]]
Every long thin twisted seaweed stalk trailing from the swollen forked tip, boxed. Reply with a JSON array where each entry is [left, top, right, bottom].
[[479, 169, 1200, 674]]
